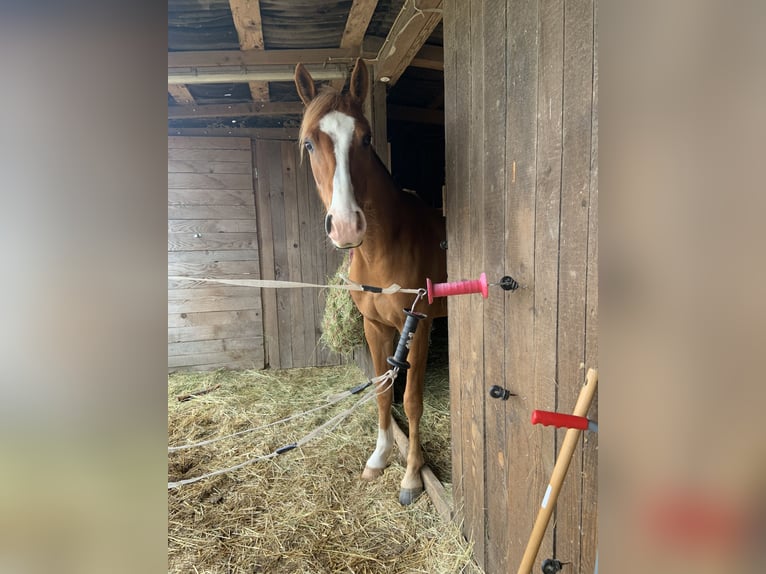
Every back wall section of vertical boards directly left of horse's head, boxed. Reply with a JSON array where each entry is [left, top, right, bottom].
[[254, 139, 352, 368]]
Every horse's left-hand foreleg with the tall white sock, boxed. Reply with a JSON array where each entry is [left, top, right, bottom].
[[362, 318, 395, 480]]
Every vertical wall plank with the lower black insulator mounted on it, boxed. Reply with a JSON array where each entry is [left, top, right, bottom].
[[484, 0, 516, 572]]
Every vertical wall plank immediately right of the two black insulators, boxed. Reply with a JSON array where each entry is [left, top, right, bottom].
[[503, 0, 554, 572]]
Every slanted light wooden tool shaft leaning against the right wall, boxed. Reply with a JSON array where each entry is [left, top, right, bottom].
[[517, 369, 598, 574]]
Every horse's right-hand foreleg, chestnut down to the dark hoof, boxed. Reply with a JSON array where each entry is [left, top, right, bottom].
[[399, 319, 431, 505]]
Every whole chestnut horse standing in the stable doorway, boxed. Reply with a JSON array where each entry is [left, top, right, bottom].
[[295, 58, 447, 505]]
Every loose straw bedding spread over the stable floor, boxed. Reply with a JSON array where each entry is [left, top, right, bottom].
[[168, 366, 480, 574]]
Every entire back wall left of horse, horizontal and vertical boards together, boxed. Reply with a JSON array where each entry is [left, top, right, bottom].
[[168, 135, 351, 371]]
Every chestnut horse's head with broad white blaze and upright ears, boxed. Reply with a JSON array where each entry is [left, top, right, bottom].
[[295, 59, 375, 249]]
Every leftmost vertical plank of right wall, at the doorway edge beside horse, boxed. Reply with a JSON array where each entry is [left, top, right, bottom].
[[444, 0, 470, 538]]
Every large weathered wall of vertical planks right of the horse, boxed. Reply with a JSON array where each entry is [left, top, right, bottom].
[[444, 0, 598, 574]]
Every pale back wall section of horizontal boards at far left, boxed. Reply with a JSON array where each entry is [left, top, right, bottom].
[[168, 137, 264, 371]]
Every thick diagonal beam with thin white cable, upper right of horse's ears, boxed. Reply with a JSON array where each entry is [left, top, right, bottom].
[[375, 0, 442, 85]]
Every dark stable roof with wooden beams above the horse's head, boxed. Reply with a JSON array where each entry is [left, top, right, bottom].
[[168, 0, 444, 130]]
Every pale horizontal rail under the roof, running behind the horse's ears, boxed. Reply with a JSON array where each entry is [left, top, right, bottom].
[[168, 64, 348, 85]]
